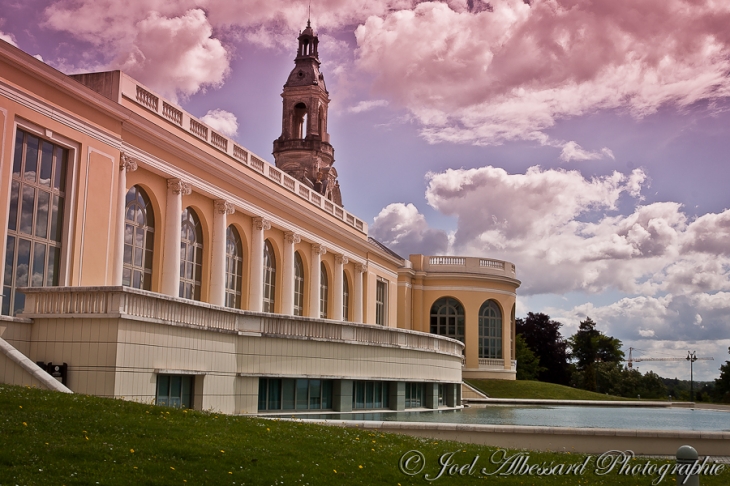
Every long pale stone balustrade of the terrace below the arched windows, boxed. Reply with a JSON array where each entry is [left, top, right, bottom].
[[19, 287, 464, 356]]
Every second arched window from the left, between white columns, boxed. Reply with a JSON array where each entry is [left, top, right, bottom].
[[180, 208, 203, 300]]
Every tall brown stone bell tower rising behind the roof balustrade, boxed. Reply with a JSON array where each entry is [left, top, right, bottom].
[[273, 20, 342, 205]]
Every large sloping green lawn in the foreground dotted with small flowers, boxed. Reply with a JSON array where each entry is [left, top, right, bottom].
[[0, 385, 730, 486]]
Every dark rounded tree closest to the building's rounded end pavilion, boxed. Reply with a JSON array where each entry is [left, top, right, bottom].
[[516, 312, 570, 385]]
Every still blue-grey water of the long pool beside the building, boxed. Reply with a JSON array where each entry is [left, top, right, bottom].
[[284, 406, 730, 432]]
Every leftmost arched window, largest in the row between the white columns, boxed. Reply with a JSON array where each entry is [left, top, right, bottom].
[[122, 186, 155, 290]]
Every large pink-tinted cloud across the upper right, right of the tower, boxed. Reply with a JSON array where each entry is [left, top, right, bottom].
[[356, 0, 730, 143]]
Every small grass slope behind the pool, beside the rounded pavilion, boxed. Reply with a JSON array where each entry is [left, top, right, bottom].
[[464, 380, 628, 400]]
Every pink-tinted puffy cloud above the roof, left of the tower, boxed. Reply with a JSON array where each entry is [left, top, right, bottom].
[[44, 0, 229, 100]]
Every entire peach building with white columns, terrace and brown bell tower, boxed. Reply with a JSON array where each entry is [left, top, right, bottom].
[[0, 26, 519, 413]]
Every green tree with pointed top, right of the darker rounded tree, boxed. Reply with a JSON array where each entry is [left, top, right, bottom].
[[568, 317, 624, 391]]
